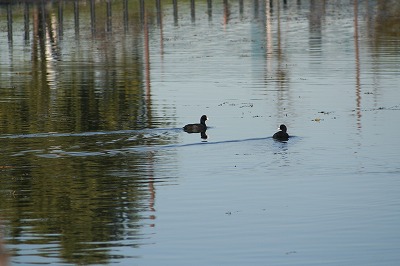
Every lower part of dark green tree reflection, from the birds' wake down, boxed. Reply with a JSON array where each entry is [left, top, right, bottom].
[[0, 134, 177, 264]]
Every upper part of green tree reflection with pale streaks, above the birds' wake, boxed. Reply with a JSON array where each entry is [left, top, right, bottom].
[[0, 1, 164, 133]]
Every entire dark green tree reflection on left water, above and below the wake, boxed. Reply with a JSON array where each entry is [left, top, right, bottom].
[[0, 1, 175, 265]]
